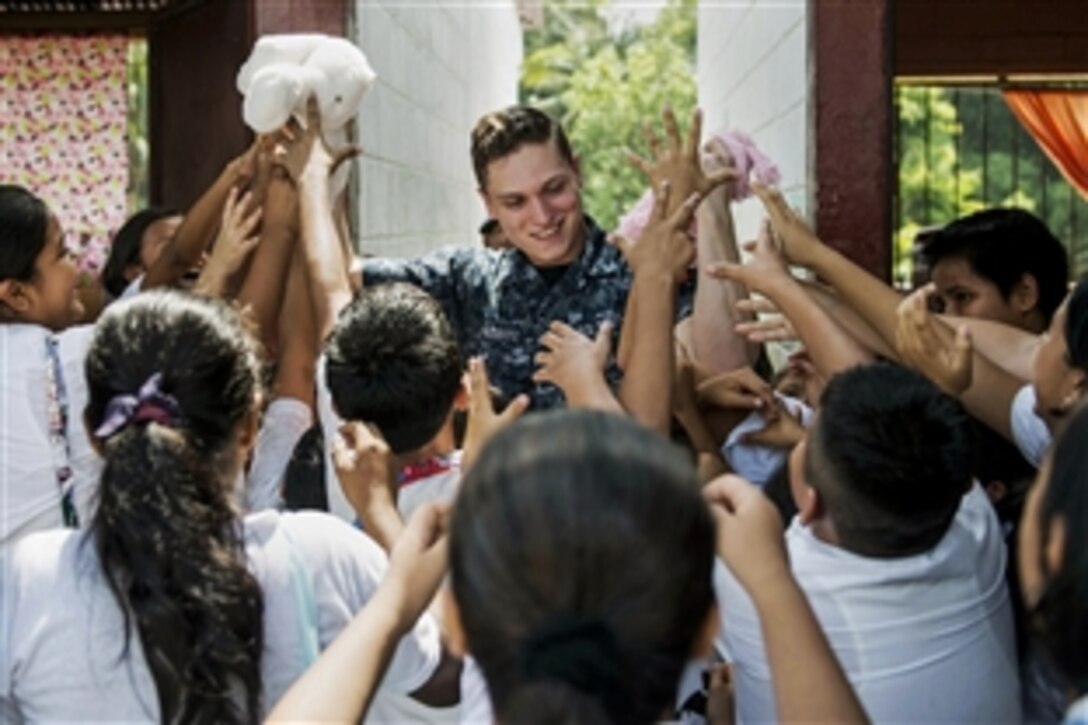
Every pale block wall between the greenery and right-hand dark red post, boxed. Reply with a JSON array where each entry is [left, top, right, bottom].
[[697, 0, 812, 241]]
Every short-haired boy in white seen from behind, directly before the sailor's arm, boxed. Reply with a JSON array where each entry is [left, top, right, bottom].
[[318, 283, 468, 549]]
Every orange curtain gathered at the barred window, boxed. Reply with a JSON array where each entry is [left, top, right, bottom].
[[1003, 90, 1088, 198]]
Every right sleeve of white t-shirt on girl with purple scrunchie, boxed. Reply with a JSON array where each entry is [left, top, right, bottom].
[[290, 513, 442, 695]]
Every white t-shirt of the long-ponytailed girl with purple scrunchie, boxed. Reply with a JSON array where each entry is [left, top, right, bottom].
[[0, 512, 441, 722]]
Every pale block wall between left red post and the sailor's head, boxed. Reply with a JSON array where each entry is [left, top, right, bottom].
[[355, 0, 522, 257]]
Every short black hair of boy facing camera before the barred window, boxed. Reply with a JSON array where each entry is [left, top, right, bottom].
[[922, 209, 1070, 324]]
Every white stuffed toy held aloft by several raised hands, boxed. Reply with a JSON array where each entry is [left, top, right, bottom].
[[237, 33, 378, 194]]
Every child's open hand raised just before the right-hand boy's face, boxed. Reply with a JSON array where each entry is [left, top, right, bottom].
[[895, 282, 973, 396]]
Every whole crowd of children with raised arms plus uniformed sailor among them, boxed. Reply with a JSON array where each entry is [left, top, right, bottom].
[[0, 85, 1088, 723]]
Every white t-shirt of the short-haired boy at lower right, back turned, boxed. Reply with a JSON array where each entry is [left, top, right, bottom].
[[715, 484, 1021, 723]]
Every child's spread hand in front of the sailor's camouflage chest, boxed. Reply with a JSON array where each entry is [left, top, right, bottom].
[[533, 320, 622, 413]]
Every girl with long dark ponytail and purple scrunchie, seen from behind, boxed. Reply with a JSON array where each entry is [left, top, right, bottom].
[[0, 292, 456, 723]]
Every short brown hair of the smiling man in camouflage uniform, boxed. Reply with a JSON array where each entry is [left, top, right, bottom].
[[472, 106, 574, 189]]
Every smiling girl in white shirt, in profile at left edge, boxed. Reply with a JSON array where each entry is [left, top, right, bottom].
[[0, 185, 97, 548]]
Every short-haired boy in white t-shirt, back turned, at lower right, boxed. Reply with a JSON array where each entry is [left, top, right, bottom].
[[716, 365, 1021, 722]]
